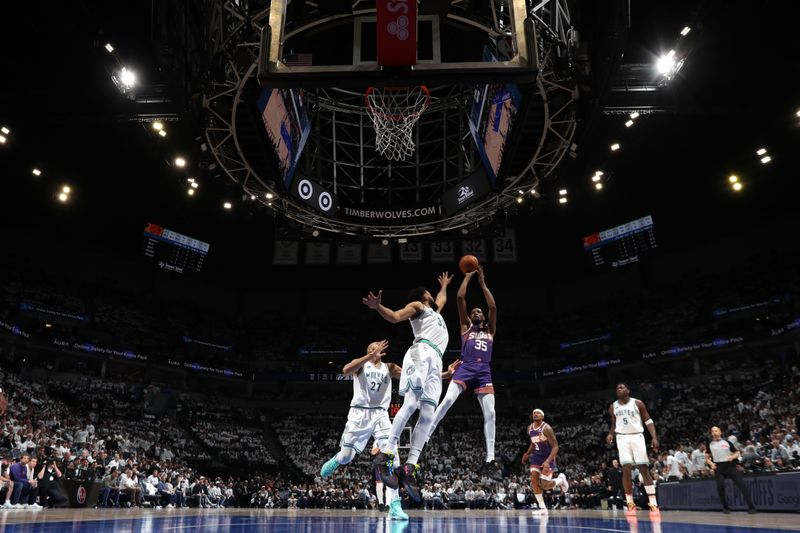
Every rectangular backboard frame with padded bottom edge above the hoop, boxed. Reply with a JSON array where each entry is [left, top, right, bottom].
[[259, 0, 538, 90]]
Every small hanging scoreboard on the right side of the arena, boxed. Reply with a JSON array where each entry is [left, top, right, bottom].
[[583, 215, 656, 268]]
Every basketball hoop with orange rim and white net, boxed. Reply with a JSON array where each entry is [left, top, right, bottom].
[[364, 85, 431, 161]]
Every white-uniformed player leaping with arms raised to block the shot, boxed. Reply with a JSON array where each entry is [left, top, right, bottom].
[[362, 272, 456, 518]]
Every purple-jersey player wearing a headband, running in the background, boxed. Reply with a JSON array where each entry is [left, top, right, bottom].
[[522, 409, 558, 514]]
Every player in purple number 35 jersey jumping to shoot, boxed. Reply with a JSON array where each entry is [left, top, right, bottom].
[[428, 266, 503, 481]]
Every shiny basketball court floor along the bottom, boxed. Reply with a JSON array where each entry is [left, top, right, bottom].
[[0, 509, 800, 533]]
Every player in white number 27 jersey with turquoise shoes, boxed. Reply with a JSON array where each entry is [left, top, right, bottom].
[[320, 340, 400, 479]]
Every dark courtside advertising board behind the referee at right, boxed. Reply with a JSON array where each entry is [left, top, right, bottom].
[[658, 472, 800, 512]]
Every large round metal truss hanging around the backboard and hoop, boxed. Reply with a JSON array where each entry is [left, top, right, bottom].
[[203, 0, 577, 238]]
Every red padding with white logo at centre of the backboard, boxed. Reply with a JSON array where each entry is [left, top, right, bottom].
[[375, 0, 417, 67]]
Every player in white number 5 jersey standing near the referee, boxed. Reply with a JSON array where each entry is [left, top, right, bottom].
[[606, 383, 658, 513]]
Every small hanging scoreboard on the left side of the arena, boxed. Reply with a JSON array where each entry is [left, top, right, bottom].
[[144, 223, 209, 274]]
